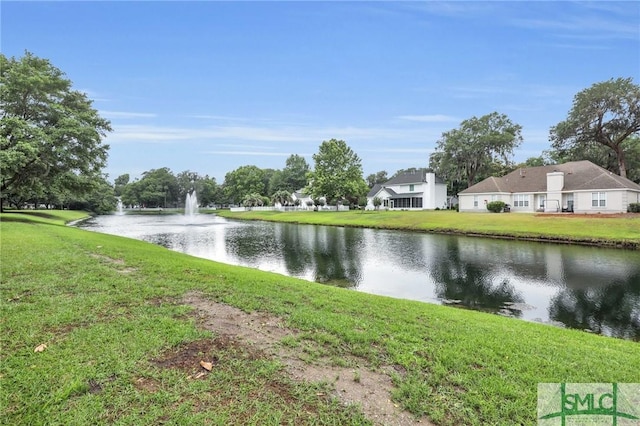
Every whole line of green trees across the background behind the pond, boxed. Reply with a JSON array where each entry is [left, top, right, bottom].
[[0, 52, 640, 213]]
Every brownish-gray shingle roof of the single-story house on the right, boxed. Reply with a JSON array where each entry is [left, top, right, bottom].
[[460, 160, 640, 194]]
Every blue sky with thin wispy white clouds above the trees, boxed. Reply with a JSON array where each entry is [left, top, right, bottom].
[[0, 1, 640, 183]]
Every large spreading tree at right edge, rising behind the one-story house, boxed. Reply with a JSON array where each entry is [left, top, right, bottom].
[[549, 78, 640, 177]]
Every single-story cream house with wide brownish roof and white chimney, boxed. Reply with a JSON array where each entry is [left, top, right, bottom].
[[458, 161, 640, 213]]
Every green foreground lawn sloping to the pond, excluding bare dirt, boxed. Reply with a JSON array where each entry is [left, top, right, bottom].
[[0, 212, 640, 425]]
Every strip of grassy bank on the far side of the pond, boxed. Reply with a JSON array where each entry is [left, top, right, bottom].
[[217, 210, 640, 249]]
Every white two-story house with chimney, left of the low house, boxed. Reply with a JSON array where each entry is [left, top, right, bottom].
[[366, 169, 447, 210]]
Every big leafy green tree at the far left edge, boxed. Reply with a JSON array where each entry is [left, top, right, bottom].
[[0, 52, 111, 210]]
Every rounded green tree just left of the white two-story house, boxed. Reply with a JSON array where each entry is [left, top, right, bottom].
[[309, 139, 368, 207]]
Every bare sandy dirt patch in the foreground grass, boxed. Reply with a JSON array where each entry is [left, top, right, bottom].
[[180, 293, 430, 426]]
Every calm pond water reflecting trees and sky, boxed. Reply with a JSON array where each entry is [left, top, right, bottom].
[[81, 215, 640, 341]]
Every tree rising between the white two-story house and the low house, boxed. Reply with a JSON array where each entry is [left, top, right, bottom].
[[429, 112, 522, 187]]
